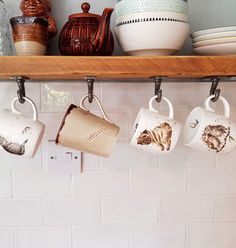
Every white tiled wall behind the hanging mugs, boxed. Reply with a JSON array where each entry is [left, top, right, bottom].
[[0, 0, 236, 248]]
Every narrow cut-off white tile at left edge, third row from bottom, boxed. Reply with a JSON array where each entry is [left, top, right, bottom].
[[0, 171, 12, 198]]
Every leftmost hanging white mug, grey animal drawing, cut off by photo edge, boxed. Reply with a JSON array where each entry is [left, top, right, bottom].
[[0, 97, 45, 158]]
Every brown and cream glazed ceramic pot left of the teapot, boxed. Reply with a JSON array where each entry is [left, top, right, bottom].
[[10, 16, 48, 56]]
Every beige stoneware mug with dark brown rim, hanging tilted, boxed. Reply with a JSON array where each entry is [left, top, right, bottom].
[[56, 96, 119, 157]]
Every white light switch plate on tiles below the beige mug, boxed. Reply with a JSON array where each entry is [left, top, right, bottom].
[[43, 140, 82, 174]]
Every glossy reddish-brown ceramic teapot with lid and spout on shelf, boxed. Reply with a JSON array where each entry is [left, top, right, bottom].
[[59, 3, 114, 56]]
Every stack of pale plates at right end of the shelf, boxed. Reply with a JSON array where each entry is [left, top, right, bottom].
[[190, 26, 236, 55]]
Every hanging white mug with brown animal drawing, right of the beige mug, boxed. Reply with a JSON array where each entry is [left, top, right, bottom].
[[130, 96, 180, 154]]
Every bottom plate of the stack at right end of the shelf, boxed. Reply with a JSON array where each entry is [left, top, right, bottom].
[[193, 42, 236, 55]]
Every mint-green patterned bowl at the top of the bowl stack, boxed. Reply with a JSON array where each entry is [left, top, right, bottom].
[[115, 0, 188, 17]]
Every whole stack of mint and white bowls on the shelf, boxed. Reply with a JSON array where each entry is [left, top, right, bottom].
[[115, 0, 189, 56]]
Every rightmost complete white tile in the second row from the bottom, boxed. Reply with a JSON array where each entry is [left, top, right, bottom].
[[160, 197, 214, 222]]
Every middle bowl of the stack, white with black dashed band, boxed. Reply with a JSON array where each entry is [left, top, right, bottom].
[[116, 11, 188, 26]]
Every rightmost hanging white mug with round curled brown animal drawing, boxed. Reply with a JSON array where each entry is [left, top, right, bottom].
[[183, 95, 236, 153]]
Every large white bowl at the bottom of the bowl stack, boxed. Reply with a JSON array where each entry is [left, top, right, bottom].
[[115, 19, 189, 56]]
